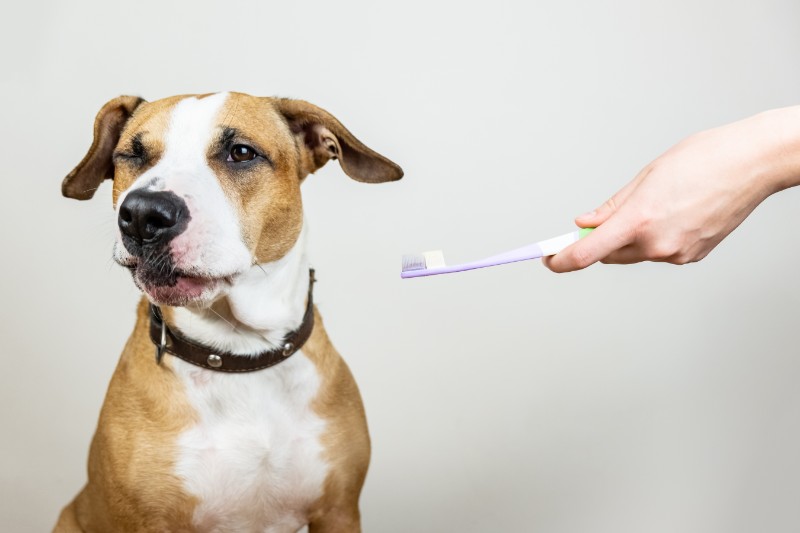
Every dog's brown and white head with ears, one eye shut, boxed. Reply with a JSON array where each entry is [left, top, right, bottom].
[[62, 93, 403, 305]]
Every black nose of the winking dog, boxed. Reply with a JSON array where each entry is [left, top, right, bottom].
[[118, 189, 189, 246]]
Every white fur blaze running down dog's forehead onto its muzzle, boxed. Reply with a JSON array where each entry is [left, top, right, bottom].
[[115, 93, 252, 286]]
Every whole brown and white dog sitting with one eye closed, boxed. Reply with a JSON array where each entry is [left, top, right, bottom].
[[55, 93, 403, 533]]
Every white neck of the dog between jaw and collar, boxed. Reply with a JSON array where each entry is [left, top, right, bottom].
[[173, 222, 309, 355]]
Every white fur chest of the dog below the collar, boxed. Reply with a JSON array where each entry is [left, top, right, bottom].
[[175, 352, 328, 531]]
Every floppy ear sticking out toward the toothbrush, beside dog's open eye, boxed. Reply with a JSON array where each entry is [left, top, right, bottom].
[[276, 98, 403, 183]]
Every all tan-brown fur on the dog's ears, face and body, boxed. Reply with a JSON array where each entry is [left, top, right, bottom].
[[54, 93, 402, 533]]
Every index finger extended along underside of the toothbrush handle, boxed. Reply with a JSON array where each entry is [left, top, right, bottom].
[[542, 211, 633, 273]]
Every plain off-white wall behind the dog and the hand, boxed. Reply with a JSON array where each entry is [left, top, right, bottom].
[[0, 0, 800, 533]]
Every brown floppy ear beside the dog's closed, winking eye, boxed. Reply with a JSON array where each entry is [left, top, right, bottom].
[[61, 96, 144, 200]]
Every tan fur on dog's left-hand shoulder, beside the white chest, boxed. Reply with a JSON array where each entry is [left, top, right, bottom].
[[56, 299, 195, 532]]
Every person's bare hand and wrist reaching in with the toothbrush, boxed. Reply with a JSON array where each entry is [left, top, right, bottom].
[[544, 106, 800, 272]]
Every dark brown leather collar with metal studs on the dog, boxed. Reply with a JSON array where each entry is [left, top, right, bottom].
[[150, 268, 316, 372]]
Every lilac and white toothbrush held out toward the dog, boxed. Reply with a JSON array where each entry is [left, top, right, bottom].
[[400, 228, 594, 278]]
